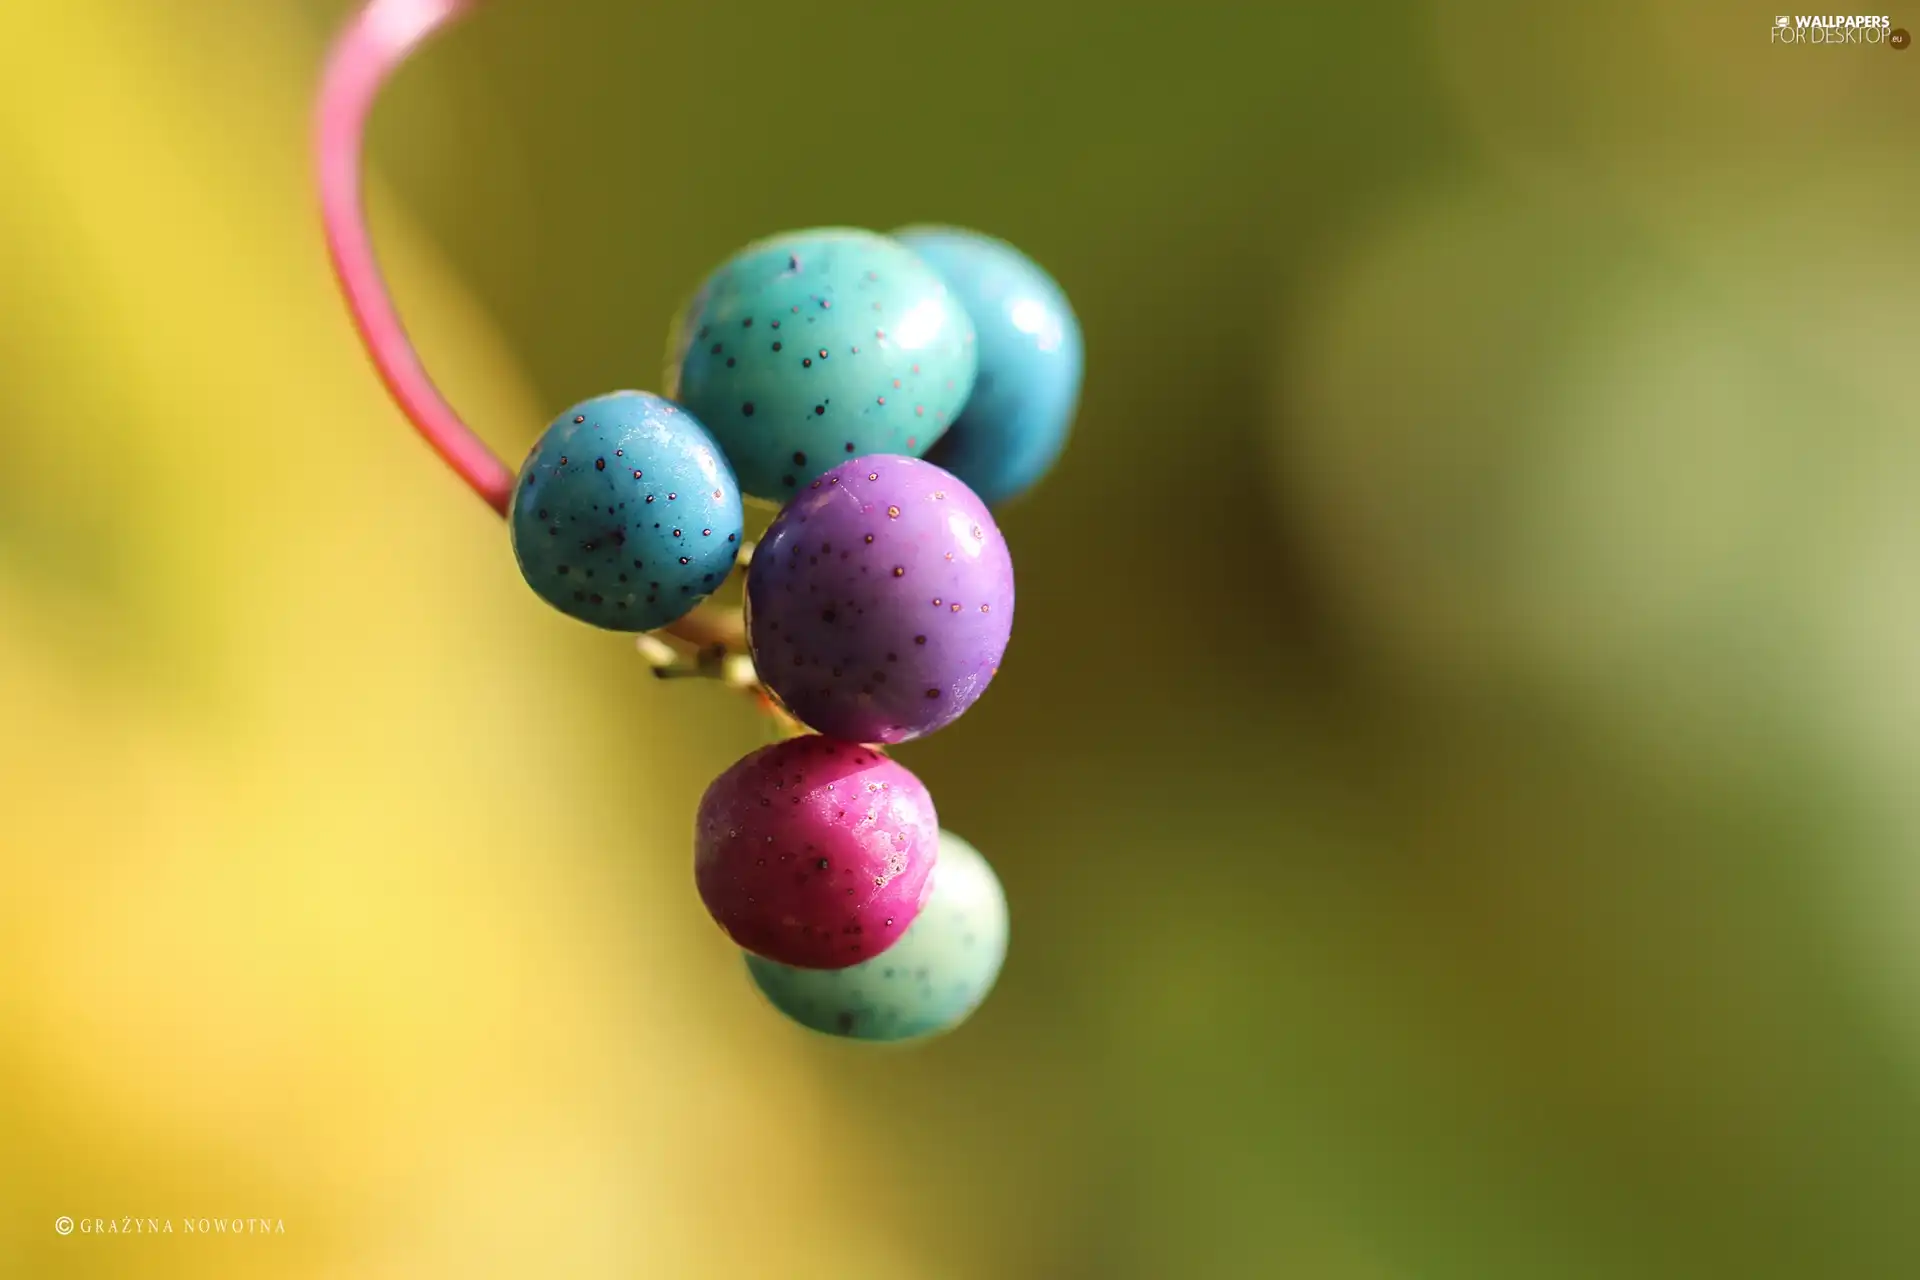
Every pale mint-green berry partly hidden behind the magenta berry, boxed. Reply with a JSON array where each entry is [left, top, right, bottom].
[[747, 831, 1008, 1040]]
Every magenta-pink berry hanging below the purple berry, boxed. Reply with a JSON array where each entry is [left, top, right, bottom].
[[693, 735, 941, 969]]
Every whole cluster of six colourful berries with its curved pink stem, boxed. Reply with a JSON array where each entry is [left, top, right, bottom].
[[319, 0, 1081, 1040]]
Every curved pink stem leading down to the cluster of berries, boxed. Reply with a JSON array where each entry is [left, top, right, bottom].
[[315, 0, 515, 514]]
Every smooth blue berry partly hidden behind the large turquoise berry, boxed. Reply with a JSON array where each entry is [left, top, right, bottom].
[[893, 226, 1085, 507]]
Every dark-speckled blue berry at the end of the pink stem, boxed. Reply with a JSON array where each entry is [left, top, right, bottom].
[[507, 391, 741, 631]]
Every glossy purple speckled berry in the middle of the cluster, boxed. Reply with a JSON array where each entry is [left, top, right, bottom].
[[747, 455, 1014, 743]]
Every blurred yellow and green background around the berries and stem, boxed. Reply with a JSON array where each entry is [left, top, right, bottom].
[[0, 0, 1920, 1280]]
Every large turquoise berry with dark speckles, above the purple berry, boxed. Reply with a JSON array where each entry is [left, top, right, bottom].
[[666, 228, 975, 505]]
